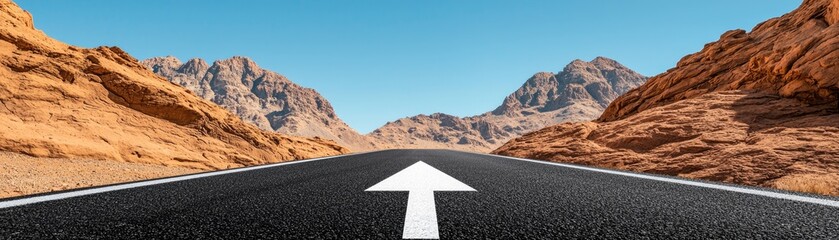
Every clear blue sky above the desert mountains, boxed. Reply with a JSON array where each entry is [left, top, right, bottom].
[[18, 0, 801, 133]]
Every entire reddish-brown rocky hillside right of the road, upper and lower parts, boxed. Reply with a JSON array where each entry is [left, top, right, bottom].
[[494, 0, 839, 195]]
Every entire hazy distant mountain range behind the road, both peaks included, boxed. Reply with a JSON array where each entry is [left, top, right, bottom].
[[146, 56, 646, 152]]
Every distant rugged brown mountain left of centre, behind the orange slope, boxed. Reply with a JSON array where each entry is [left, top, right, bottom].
[[141, 56, 374, 150]]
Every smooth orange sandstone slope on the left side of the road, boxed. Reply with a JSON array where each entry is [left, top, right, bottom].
[[0, 0, 347, 169]]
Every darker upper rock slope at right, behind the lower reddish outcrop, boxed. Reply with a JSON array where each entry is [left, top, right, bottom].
[[599, 0, 839, 121]]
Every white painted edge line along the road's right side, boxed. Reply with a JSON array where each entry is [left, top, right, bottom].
[[477, 153, 839, 207]]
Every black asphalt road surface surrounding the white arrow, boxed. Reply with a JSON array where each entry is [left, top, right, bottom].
[[0, 150, 839, 239]]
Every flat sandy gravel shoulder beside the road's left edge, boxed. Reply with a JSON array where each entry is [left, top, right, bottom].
[[0, 152, 202, 198]]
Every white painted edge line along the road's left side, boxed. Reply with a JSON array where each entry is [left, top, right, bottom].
[[0, 151, 379, 209]]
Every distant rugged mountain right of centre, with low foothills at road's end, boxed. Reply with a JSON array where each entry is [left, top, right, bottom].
[[367, 57, 646, 152]]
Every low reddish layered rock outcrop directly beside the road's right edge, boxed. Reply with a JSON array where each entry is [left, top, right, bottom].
[[493, 90, 839, 195]]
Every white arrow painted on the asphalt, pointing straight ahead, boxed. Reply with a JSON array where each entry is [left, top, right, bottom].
[[365, 162, 476, 239]]
